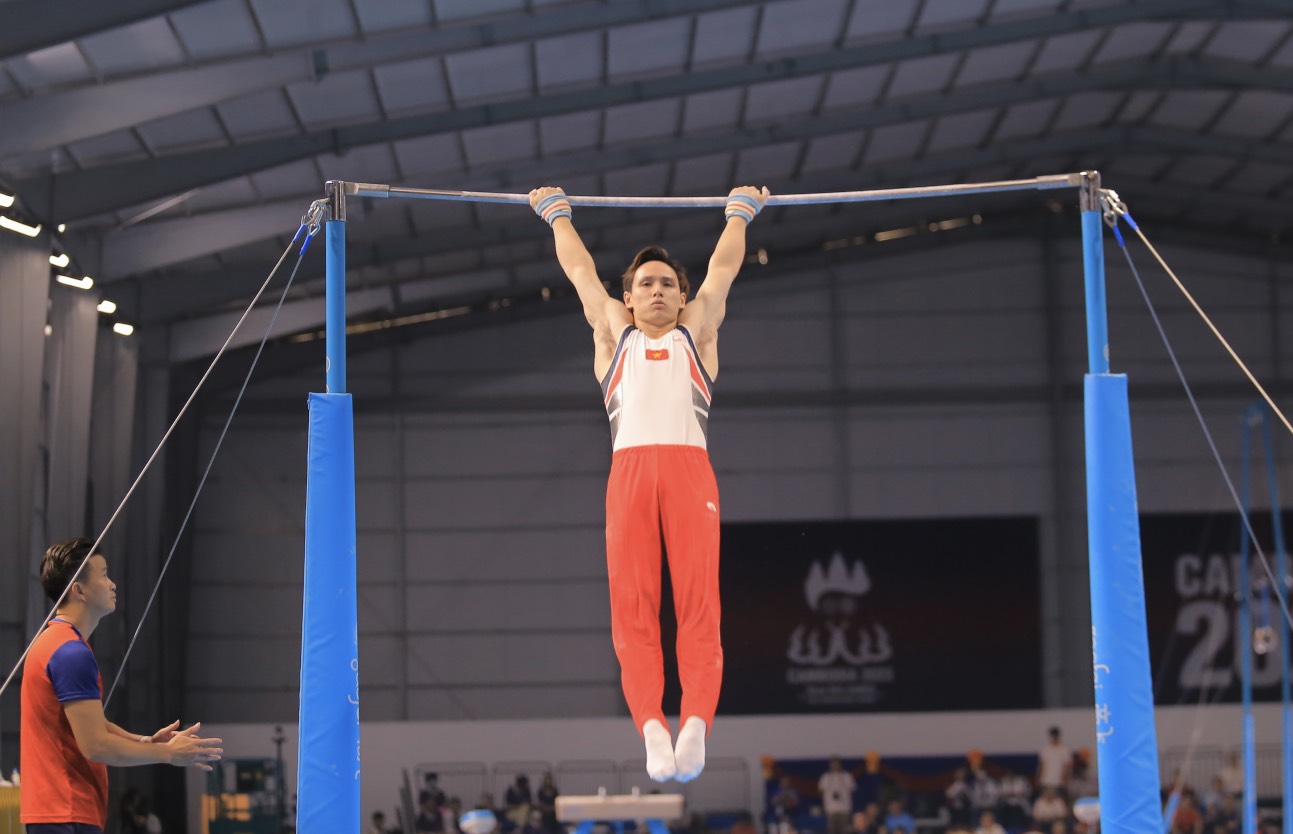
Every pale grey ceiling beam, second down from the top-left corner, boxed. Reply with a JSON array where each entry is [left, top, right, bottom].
[[0, 0, 746, 159]]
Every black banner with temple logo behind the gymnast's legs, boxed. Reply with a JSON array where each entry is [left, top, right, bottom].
[[665, 519, 1042, 715]]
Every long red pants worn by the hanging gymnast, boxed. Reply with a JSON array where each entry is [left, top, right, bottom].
[[606, 445, 723, 732]]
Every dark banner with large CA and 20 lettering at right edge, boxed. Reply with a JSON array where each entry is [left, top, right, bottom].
[[1140, 512, 1293, 705]]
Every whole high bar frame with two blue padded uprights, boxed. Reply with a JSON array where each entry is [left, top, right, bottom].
[[297, 172, 1174, 834]]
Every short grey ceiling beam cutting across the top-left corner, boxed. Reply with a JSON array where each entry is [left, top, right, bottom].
[[0, 0, 206, 59]]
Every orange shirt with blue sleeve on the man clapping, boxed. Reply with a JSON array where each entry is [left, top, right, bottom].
[[19, 619, 107, 830]]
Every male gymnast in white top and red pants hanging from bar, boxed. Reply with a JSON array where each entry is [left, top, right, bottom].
[[530, 186, 768, 782]]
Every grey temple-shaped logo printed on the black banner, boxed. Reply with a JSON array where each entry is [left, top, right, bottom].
[[786, 552, 895, 707]]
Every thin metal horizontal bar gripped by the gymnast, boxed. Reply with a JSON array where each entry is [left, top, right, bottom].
[[341, 172, 1086, 208]]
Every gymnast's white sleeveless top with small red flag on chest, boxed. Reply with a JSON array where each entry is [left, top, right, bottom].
[[601, 325, 714, 451]]
